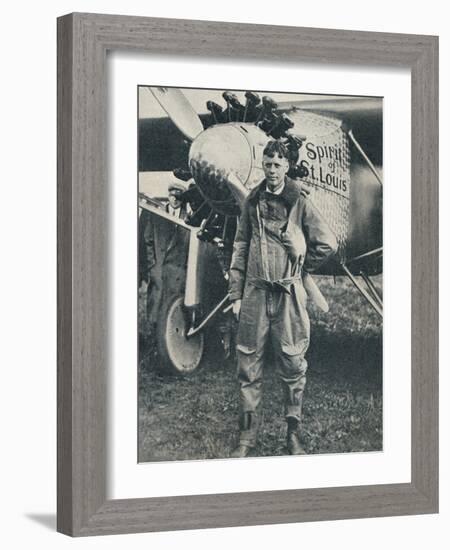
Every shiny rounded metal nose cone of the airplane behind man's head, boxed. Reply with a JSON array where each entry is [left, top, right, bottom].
[[189, 123, 269, 216]]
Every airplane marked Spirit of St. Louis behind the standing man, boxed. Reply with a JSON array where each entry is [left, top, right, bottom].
[[138, 87, 383, 374]]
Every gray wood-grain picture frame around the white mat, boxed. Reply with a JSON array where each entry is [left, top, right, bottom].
[[57, 13, 438, 536]]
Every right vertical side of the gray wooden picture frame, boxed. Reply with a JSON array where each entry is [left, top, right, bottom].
[[411, 35, 439, 509]]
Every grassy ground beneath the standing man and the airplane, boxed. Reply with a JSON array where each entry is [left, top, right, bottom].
[[139, 277, 382, 462]]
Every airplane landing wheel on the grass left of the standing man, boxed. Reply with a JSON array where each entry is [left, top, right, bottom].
[[157, 296, 204, 375]]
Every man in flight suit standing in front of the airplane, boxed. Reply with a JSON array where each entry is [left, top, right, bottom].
[[230, 141, 337, 458]]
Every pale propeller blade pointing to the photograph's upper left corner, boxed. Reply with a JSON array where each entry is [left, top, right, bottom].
[[147, 86, 203, 141]]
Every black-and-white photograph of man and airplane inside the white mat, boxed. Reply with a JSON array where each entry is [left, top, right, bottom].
[[137, 85, 383, 462]]
